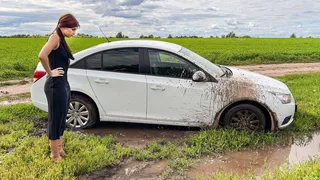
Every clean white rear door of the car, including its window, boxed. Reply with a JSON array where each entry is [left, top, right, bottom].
[[86, 48, 146, 121]]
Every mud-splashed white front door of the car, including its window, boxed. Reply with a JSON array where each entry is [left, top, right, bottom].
[[145, 49, 212, 125]]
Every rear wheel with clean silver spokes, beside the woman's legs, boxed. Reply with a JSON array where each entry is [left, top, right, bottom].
[[66, 94, 98, 130]]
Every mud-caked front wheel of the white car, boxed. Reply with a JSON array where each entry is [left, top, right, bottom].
[[223, 104, 266, 131]]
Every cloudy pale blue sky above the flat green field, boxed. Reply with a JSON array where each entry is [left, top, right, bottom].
[[0, 0, 320, 38]]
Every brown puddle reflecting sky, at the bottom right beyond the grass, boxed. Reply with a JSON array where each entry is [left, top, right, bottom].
[[186, 133, 320, 178]]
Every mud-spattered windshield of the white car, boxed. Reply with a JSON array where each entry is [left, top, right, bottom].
[[179, 47, 224, 76]]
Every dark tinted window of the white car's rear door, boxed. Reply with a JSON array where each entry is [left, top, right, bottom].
[[102, 48, 139, 73]]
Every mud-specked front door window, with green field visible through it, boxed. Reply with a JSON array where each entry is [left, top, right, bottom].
[[148, 49, 198, 79]]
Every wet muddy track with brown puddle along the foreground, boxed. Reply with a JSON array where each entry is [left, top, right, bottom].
[[78, 131, 320, 180]]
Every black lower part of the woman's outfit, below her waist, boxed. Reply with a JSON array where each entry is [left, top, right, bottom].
[[44, 78, 70, 140]]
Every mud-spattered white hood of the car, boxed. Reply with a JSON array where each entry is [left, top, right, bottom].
[[226, 66, 290, 93]]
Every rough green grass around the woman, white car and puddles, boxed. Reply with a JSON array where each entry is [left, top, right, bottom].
[[0, 73, 320, 179]]
